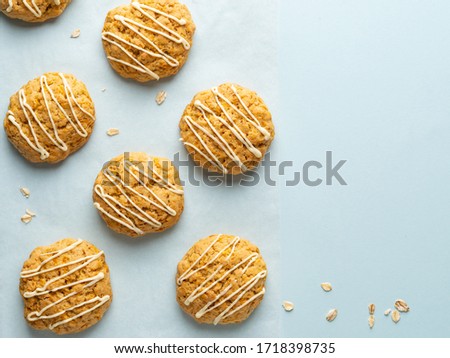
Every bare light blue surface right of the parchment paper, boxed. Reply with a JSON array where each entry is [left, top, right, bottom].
[[278, 0, 450, 337]]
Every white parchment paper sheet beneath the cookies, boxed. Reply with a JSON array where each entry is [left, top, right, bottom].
[[0, 0, 281, 337]]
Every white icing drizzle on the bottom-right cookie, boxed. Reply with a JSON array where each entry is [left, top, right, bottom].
[[177, 235, 267, 325]]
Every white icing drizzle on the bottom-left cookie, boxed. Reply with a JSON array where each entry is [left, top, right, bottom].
[[20, 239, 111, 329]]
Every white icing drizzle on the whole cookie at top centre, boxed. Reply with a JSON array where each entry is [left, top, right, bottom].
[[102, 1, 191, 80]]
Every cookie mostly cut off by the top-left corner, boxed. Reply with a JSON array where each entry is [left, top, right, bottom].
[[0, 0, 72, 22]]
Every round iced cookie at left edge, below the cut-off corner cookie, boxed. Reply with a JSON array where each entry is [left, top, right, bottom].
[[4, 72, 95, 163]]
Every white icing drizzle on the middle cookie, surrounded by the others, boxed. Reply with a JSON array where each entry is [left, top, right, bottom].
[[94, 160, 183, 235]]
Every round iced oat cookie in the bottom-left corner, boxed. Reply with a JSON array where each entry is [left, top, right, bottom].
[[19, 239, 112, 334]]
